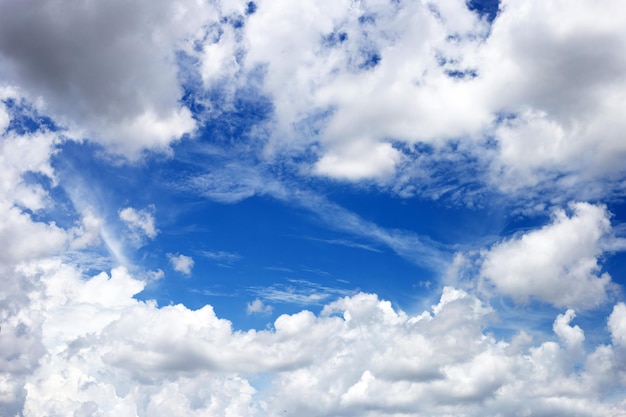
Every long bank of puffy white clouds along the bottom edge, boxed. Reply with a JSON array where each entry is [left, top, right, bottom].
[[0, 259, 626, 417]]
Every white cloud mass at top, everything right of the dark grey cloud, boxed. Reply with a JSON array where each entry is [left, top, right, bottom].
[[184, 0, 626, 197]]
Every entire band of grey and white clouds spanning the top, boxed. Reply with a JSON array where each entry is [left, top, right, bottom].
[[0, 0, 626, 194]]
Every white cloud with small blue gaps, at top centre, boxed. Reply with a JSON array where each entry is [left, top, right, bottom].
[[245, 1, 490, 173]]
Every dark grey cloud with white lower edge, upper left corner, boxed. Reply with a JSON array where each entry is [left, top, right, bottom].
[[0, 0, 210, 158]]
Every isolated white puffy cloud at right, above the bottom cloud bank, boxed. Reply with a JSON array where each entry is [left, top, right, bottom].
[[481, 203, 612, 308]]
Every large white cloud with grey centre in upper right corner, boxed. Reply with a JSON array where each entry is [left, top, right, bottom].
[[479, 1, 626, 191]]
